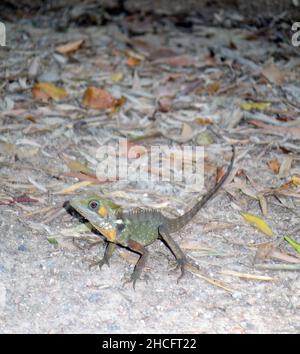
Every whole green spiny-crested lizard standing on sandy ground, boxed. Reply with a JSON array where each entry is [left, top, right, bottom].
[[69, 146, 235, 288]]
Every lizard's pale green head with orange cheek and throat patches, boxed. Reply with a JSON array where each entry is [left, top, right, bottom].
[[70, 194, 123, 242]]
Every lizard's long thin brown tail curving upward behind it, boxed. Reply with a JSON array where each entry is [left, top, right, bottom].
[[167, 145, 235, 232]]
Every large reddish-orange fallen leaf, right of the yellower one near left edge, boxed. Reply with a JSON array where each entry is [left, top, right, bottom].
[[82, 86, 118, 109]]
